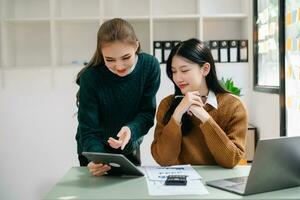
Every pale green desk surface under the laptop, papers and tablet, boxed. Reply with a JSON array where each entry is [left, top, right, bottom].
[[44, 166, 300, 200]]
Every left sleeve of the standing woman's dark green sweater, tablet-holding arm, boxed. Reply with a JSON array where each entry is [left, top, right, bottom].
[[78, 74, 105, 152]]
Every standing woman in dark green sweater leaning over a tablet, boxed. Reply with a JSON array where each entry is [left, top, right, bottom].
[[76, 18, 160, 176]]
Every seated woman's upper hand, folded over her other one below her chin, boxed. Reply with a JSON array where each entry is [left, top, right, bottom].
[[173, 91, 203, 123]]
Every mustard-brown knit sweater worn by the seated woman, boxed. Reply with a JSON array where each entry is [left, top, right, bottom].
[[151, 94, 248, 168]]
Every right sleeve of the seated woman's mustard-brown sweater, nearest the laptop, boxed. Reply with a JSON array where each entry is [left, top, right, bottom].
[[200, 101, 248, 168]]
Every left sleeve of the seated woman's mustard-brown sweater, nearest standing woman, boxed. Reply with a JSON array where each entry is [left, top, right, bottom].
[[151, 99, 182, 166]]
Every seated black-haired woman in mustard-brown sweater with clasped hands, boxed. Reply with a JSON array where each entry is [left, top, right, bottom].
[[151, 39, 248, 168]]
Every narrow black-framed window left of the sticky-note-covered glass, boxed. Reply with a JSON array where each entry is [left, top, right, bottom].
[[253, 0, 284, 93]]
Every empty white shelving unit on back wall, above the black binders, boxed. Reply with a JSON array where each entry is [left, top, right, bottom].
[[0, 0, 249, 69]]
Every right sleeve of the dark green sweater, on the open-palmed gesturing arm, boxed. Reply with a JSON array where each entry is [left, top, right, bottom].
[[127, 59, 160, 143]]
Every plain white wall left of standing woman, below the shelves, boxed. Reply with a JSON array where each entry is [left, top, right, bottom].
[[0, 69, 78, 200]]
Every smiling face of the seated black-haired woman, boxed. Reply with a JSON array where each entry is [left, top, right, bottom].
[[171, 55, 210, 94]]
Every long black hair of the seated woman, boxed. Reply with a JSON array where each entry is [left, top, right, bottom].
[[163, 38, 229, 134]]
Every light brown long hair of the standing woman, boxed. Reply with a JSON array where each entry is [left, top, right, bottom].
[[76, 18, 141, 106]]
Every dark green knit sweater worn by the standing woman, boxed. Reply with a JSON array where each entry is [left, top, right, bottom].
[[76, 53, 160, 155]]
